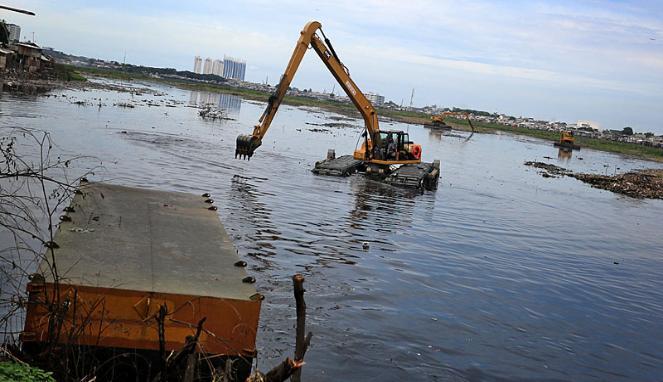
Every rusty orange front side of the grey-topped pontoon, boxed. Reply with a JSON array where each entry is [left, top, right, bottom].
[[22, 282, 260, 357]]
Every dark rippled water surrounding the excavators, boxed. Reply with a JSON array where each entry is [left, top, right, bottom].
[[0, 81, 663, 381]]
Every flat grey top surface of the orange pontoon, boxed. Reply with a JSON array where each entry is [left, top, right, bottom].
[[40, 183, 256, 300]]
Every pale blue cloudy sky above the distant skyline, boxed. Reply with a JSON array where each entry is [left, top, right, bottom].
[[0, 0, 663, 134]]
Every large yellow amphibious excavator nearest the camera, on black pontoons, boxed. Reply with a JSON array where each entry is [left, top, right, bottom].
[[235, 21, 440, 189]]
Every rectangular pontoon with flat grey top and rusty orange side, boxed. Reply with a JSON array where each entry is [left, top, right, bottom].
[[21, 183, 262, 359]]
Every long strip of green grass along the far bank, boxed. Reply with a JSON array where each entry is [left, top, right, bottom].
[[75, 63, 663, 162]]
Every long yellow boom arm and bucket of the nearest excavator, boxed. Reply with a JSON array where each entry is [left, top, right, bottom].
[[235, 21, 380, 158]]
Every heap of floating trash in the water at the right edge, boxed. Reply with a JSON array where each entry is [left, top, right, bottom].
[[525, 161, 663, 199]]
